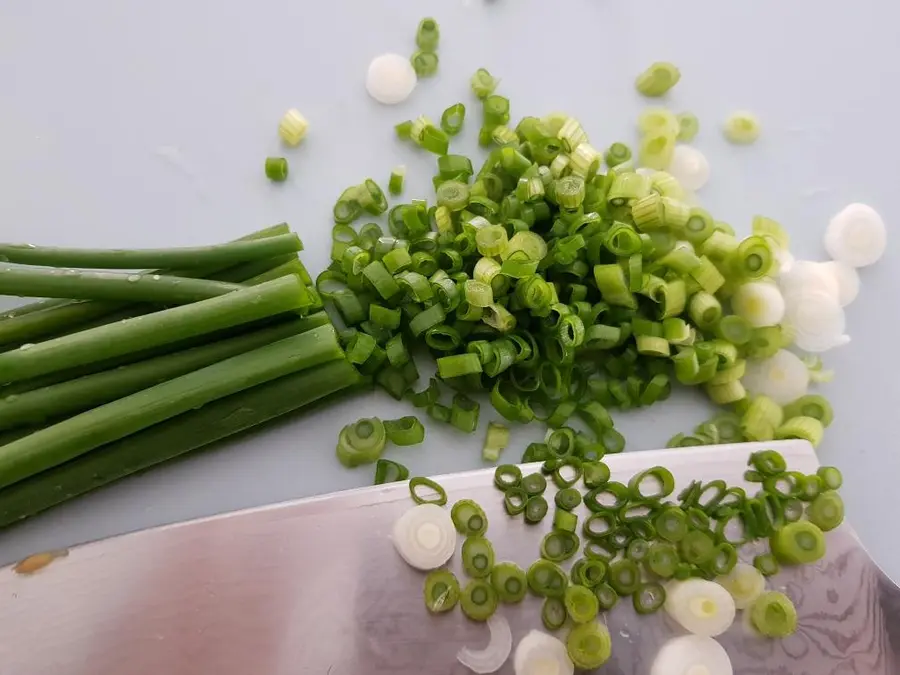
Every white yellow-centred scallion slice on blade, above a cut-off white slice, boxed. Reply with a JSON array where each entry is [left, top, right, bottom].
[[665, 579, 735, 637]]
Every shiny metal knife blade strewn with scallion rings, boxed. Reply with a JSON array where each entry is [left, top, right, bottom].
[[0, 441, 900, 675]]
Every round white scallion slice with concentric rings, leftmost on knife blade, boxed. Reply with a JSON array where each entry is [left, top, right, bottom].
[[392, 504, 456, 570]]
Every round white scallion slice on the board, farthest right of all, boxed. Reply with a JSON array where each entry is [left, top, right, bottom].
[[825, 204, 887, 267]]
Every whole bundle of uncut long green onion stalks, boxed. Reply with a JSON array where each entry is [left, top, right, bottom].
[[0, 225, 362, 526]]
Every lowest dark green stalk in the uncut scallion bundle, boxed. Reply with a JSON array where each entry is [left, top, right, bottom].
[[0, 359, 361, 527]]
